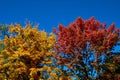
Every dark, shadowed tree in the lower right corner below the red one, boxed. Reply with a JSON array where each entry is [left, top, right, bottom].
[[98, 52, 120, 80]]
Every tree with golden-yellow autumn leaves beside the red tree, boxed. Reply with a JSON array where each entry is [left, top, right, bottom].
[[0, 24, 59, 80]]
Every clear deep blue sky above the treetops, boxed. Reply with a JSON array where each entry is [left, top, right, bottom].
[[0, 0, 120, 32]]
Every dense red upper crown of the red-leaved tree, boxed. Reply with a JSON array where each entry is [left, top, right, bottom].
[[53, 17, 119, 55]]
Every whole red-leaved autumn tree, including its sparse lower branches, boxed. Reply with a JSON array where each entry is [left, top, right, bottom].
[[53, 17, 120, 80]]
